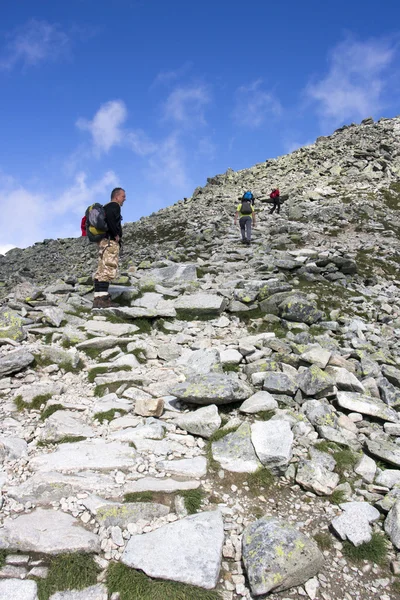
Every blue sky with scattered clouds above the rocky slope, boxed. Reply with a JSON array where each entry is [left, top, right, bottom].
[[0, 0, 400, 253]]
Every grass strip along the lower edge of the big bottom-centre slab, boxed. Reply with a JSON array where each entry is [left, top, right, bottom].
[[106, 563, 222, 600]]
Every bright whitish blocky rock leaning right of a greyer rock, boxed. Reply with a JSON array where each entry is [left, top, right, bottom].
[[251, 420, 293, 468]]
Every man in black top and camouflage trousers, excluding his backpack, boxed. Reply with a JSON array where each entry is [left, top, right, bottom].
[[93, 188, 126, 308]]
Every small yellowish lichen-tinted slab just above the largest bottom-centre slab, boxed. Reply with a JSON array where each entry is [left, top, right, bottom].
[[96, 502, 169, 529]]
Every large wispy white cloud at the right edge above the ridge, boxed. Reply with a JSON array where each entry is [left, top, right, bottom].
[[306, 38, 396, 124]]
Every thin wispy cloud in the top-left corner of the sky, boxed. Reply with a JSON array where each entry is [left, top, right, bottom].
[[0, 19, 70, 70]]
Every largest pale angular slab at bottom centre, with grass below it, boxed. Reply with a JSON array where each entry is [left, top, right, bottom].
[[121, 511, 224, 590]]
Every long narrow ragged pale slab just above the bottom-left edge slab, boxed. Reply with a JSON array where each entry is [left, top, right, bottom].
[[7, 471, 123, 506]]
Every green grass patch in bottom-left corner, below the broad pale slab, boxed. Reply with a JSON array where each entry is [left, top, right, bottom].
[[36, 554, 100, 600]]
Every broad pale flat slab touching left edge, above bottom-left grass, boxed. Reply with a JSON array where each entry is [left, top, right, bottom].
[[0, 508, 100, 555]]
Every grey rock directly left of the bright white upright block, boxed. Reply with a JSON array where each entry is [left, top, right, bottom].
[[211, 423, 262, 473]]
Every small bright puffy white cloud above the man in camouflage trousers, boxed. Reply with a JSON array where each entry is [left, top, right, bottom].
[[76, 100, 128, 154]]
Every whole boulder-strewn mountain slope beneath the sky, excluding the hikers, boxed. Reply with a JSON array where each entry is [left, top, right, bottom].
[[0, 117, 400, 600]]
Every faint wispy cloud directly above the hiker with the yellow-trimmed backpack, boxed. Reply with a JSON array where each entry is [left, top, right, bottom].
[[232, 79, 282, 129]]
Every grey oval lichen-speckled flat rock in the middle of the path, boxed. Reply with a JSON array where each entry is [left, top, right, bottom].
[[169, 373, 252, 405]]
